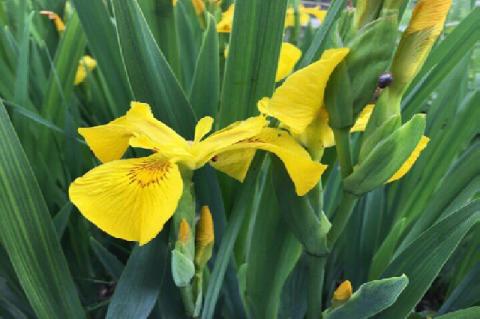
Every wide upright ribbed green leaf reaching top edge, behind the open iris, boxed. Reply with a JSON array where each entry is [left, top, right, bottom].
[[218, 0, 287, 127]]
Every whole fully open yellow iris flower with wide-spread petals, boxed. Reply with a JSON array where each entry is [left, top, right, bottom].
[[69, 102, 325, 244]]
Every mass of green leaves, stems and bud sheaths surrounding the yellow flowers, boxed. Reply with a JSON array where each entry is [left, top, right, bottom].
[[0, 0, 480, 319]]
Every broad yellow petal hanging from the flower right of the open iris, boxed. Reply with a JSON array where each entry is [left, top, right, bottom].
[[258, 48, 349, 134]]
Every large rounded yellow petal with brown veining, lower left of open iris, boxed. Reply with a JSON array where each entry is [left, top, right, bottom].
[[69, 155, 183, 245]]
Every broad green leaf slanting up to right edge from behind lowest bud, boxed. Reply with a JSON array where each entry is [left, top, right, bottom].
[[376, 201, 480, 319]]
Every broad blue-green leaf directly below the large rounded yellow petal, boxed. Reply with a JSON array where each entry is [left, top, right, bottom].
[[106, 235, 169, 319]]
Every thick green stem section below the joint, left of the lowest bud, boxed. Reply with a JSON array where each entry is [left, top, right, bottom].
[[306, 254, 327, 319]]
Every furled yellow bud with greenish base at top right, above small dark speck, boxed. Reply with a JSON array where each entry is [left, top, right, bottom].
[[392, 0, 452, 94]]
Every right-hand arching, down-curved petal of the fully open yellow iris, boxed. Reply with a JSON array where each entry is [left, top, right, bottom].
[[212, 128, 326, 196]]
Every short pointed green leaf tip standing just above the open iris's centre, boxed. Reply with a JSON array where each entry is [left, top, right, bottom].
[[190, 13, 220, 118]]
